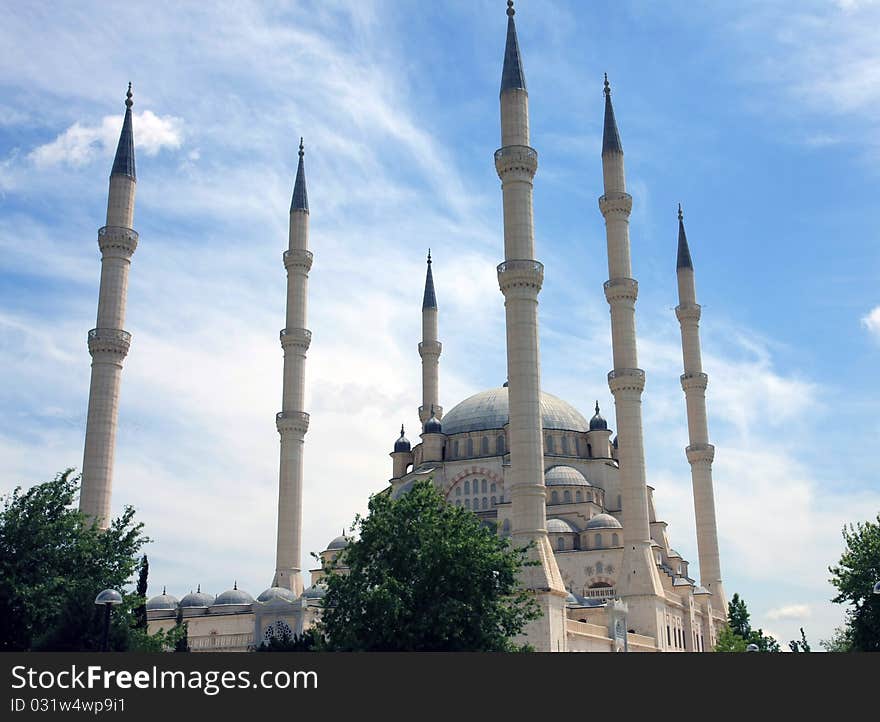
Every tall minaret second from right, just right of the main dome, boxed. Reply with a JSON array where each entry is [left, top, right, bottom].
[[599, 75, 665, 643]]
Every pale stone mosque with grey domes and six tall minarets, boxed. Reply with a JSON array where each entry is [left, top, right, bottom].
[[80, 1, 726, 652]]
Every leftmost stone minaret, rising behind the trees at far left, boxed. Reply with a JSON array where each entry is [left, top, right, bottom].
[[79, 83, 138, 529]]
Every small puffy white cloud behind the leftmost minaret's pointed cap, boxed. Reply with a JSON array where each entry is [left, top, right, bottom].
[[29, 110, 183, 167]]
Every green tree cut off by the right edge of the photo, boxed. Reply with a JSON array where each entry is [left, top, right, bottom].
[[823, 514, 880, 652]]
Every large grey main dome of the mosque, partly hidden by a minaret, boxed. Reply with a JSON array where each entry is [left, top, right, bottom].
[[443, 386, 589, 435]]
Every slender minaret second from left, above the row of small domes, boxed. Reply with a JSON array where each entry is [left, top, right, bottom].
[[273, 138, 312, 596]]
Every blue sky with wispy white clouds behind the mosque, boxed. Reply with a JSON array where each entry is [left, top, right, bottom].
[[0, 0, 880, 643]]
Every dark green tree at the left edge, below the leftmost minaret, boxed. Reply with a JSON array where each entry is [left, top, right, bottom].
[[0, 469, 179, 651]]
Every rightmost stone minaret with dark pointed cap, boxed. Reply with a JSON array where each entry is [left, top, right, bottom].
[[675, 205, 727, 611]]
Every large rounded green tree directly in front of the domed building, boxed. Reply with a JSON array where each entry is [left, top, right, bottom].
[[317, 480, 540, 651]]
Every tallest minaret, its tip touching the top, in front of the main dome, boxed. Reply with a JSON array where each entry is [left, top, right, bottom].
[[495, 0, 567, 652]]
